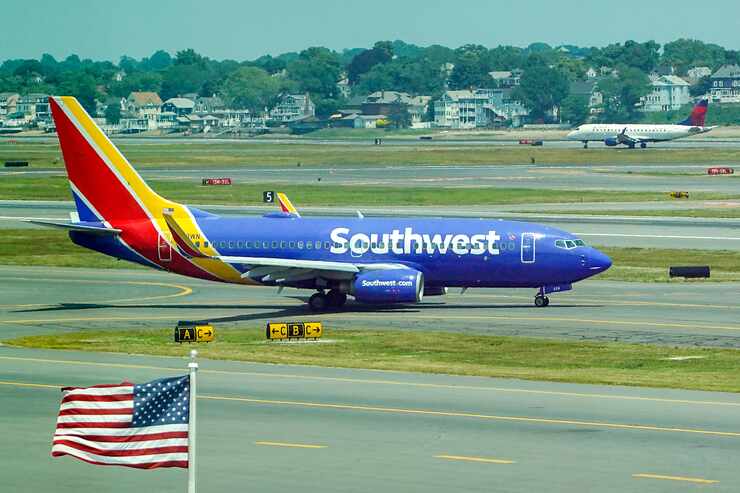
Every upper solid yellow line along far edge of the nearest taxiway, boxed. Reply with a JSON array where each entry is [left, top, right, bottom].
[[0, 356, 740, 407]]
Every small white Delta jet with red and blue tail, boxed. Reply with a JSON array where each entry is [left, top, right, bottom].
[[566, 99, 716, 149]]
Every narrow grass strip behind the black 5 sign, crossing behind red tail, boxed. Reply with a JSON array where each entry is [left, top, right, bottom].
[[0, 175, 740, 207]]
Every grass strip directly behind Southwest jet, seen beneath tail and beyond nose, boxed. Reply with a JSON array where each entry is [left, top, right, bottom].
[[0, 229, 740, 282]]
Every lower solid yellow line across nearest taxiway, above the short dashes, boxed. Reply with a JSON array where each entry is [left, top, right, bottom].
[[0, 378, 740, 438]]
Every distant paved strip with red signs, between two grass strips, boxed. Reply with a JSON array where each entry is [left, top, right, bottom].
[[5, 161, 740, 194]]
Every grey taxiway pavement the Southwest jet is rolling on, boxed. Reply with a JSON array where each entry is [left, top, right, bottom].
[[0, 266, 740, 348]]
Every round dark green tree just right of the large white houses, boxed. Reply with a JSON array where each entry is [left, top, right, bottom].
[[515, 65, 569, 120]]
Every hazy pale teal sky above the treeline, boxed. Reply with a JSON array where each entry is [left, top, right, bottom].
[[0, 0, 740, 61]]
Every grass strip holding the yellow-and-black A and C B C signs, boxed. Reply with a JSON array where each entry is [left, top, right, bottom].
[[4, 325, 740, 392]]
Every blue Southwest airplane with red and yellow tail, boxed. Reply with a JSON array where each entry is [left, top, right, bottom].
[[34, 97, 611, 311]]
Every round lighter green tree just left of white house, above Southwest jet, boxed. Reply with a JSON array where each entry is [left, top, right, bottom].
[[222, 67, 280, 114]]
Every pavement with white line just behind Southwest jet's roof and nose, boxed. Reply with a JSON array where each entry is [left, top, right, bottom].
[[0, 201, 740, 250]]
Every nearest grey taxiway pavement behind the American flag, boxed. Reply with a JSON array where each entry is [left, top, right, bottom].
[[0, 347, 740, 493]]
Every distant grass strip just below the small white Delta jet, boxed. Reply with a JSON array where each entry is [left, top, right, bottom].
[[0, 136, 739, 169]]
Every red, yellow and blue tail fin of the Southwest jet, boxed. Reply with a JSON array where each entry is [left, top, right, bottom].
[[49, 96, 178, 222]]
